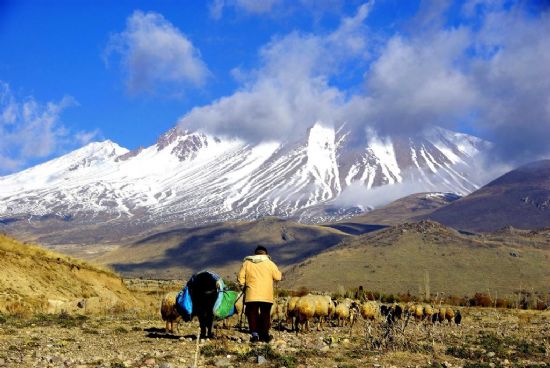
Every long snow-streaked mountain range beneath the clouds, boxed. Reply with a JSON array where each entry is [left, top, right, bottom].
[[0, 123, 487, 243]]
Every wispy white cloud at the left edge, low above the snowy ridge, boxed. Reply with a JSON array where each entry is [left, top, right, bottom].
[[0, 81, 98, 174]]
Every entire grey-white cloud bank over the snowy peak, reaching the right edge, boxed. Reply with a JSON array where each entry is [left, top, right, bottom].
[[180, 1, 550, 163]]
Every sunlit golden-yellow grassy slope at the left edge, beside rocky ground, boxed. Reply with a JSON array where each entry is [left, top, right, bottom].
[[0, 235, 147, 314]]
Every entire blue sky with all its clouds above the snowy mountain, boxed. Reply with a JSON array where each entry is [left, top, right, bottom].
[[0, 0, 550, 174]]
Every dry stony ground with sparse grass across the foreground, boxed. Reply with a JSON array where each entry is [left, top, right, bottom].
[[0, 309, 550, 368]]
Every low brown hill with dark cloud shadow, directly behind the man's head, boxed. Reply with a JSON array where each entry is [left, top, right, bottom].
[[96, 217, 349, 280]]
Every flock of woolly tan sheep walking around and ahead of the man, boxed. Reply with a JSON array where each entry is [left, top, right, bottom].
[[160, 293, 462, 333]]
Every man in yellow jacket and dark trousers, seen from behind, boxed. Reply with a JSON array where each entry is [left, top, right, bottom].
[[239, 245, 282, 342]]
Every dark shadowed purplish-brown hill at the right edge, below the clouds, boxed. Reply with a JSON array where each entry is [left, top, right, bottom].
[[426, 160, 550, 232]]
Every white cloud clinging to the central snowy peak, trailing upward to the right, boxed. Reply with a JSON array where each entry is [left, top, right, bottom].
[[180, 5, 369, 140]]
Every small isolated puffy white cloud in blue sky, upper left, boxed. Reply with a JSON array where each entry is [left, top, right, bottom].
[[105, 11, 210, 94]]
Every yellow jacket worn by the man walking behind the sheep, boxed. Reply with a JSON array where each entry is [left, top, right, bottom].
[[239, 254, 283, 303]]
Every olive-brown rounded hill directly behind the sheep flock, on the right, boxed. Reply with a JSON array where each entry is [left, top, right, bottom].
[[283, 221, 550, 296]]
